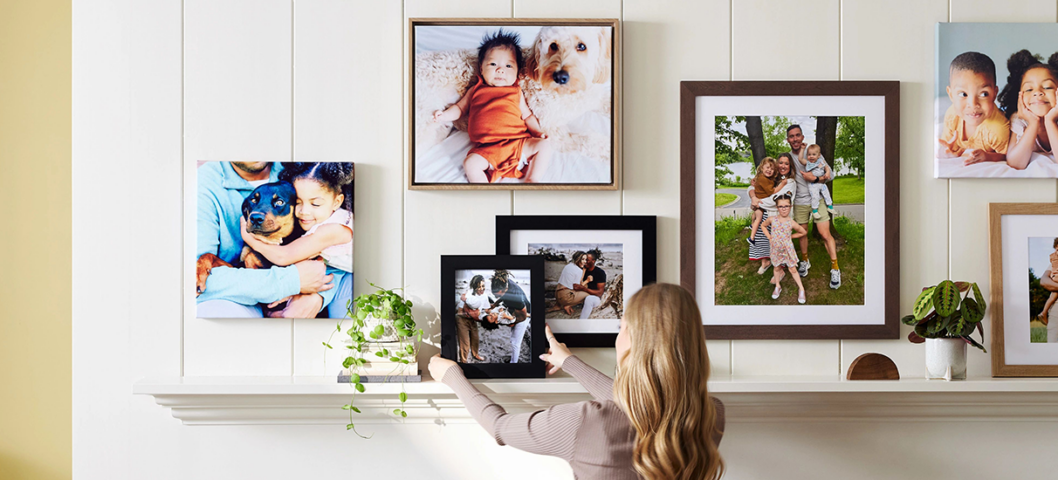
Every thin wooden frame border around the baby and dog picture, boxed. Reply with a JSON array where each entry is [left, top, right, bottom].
[[405, 18, 621, 190]]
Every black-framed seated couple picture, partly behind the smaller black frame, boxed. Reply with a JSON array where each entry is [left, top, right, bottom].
[[496, 216, 657, 347]]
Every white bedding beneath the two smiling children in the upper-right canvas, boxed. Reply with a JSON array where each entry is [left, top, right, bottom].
[[933, 96, 1058, 179]]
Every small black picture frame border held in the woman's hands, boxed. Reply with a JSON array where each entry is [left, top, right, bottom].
[[441, 255, 547, 379]]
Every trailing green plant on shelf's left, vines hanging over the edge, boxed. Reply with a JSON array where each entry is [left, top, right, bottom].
[[323, 283, 423, 438]]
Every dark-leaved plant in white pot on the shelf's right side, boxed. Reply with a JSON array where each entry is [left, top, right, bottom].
[[901, 280, 988, 380]]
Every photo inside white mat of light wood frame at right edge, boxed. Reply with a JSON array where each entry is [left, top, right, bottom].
[[1028, 237, 1058, 344]]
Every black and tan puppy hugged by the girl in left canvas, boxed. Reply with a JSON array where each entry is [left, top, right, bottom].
[[195, 182, 305, 296]]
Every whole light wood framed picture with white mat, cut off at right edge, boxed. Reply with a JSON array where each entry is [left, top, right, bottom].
[[988, 203, 1058, 376]]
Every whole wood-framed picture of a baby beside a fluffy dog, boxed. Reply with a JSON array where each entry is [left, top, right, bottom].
[[408, 18, 621, 190]]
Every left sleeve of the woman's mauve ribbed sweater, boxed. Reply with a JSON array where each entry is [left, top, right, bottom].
[[441, 368, 599, 461]]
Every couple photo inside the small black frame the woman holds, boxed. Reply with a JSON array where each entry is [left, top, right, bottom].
[[452, 269, 533, 364]]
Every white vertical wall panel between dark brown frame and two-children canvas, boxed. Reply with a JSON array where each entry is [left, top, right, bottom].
[[841, 0, 948, 377]]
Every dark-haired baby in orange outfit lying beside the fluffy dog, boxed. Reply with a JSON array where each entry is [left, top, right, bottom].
[[434, 29, 551, 183]]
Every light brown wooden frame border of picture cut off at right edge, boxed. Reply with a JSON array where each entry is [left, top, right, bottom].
[[988, 203, 1058, 376]]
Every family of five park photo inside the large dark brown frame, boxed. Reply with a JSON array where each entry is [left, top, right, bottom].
[[714, 115, 867, 306]]
